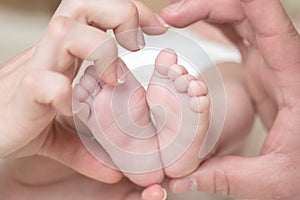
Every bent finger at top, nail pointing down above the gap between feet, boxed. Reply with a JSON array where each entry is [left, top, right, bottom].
[[54, 0, 143, 51]]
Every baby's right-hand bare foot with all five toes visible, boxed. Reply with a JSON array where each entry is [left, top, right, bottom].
[[147, 50, 209, 178]]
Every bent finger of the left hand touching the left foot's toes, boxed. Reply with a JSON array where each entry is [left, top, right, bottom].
[[32, 17, 117, 85]]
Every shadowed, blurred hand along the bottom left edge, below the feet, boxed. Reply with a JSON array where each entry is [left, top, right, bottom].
[[0, 156, 164, 200]]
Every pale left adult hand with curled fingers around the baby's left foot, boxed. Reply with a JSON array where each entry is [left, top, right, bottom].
[[0, 0, 166, 183]]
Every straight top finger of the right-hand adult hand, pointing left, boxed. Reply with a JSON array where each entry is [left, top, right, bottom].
[[161, 0, 245, 27]]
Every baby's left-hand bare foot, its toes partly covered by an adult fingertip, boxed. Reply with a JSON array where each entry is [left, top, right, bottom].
[[75, 63, 164, 186]]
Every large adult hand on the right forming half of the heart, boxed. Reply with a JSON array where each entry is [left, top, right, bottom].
[[161, 0, 300, 199]]
